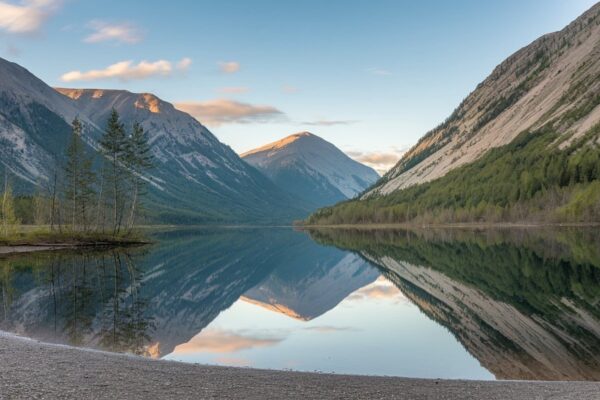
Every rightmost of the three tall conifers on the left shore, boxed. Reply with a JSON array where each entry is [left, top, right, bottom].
[[126, 122, 154, 230]]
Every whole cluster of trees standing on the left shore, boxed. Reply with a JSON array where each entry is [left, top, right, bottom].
[[0, 109, 153, 237]]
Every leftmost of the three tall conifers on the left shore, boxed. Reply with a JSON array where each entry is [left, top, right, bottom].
[[64, 118, 95, 231]]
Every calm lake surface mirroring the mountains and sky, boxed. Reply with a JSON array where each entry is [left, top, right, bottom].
[[0, 228, 600, 380]]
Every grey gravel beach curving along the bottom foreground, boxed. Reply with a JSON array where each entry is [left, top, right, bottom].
[[0, 333, 600, 400]]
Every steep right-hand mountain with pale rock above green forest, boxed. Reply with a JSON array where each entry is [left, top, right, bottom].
[[315, 4, 600, 222]]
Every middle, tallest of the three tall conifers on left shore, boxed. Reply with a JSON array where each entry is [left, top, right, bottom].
[[100, 108, 127, 235]]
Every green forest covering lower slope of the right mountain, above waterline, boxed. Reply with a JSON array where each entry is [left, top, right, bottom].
[[306, 122, 600, 225]]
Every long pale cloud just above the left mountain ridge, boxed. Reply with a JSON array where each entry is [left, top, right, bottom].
[[60, 58, 191, 82]]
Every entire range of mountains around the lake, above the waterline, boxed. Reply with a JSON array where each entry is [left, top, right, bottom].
[[0, 5, 600, 225]]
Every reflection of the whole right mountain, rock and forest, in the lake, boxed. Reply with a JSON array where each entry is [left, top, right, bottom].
[[312, 230, 600, 380]]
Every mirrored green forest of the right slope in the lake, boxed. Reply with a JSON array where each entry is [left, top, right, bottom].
[[310, 229, 600, 318]]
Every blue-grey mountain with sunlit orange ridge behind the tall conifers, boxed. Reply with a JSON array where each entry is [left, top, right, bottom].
[[56, 88, 305, 222]]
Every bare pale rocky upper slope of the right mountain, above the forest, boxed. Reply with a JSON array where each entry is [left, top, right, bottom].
[[367, 4, 600, 196]]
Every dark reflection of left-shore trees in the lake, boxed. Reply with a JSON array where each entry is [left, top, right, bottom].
[[0, 249, 153, 354]]
